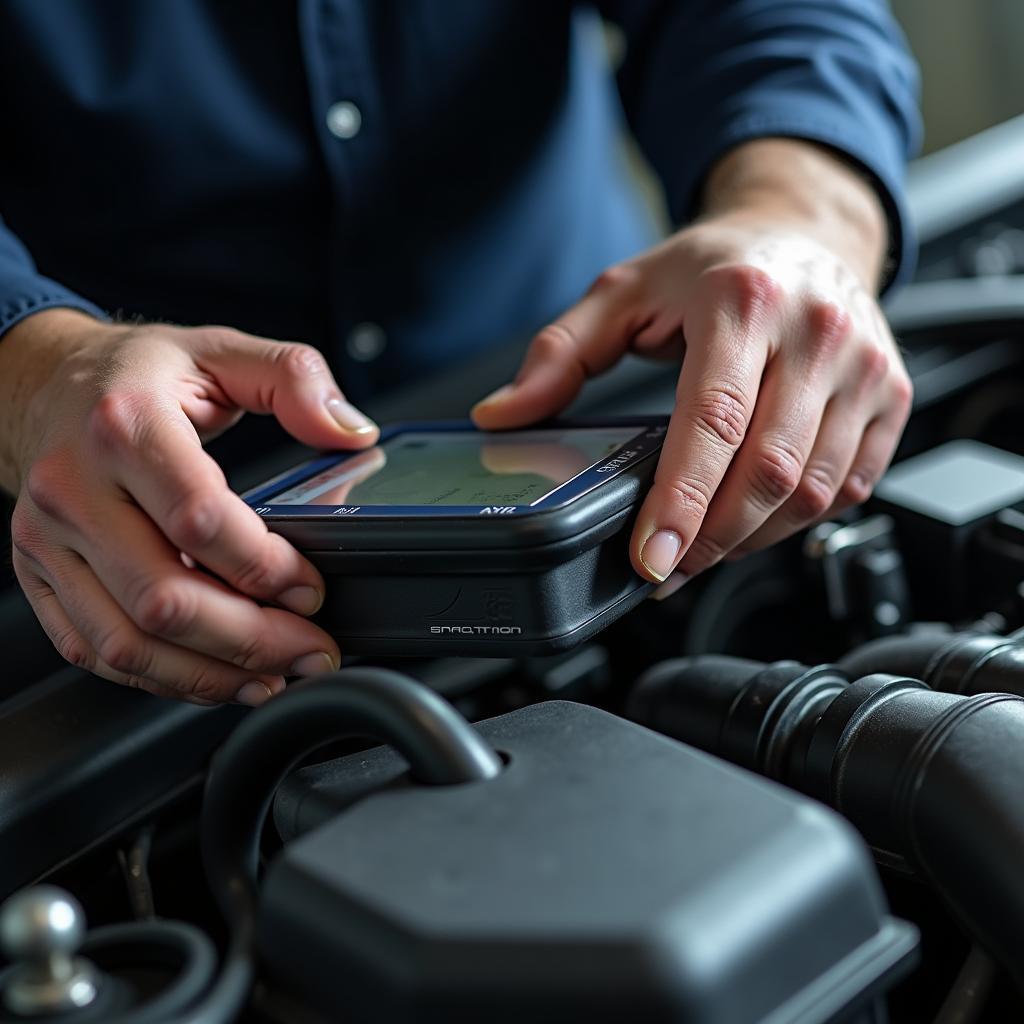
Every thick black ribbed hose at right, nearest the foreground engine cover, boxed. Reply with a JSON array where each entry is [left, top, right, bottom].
[[630, 657, 1024, 987]]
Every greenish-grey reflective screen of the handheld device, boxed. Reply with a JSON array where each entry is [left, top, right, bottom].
[[267, 426, 642, 506]]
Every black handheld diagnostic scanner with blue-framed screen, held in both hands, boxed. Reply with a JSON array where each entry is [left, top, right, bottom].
[[244, 417, 668, 657]]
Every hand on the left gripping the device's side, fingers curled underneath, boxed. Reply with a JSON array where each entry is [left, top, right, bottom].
[[0, 309, 378, 705]]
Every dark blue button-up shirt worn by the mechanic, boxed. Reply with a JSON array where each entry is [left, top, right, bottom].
[[0, 0, 918, 398]]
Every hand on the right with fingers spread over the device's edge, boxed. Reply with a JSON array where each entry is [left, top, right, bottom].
[[473, 143, 911, 582]]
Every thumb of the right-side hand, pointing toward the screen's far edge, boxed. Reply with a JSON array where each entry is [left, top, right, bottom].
[[472, 266, 643, 430]]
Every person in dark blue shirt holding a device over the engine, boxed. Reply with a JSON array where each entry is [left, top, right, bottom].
[[0, 0, 919, 705]]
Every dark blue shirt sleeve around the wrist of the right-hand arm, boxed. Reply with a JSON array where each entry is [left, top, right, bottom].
[[605, 0, 921, 287]]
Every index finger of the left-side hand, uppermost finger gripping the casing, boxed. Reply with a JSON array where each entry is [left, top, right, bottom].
[[91, 395, 324, 615]]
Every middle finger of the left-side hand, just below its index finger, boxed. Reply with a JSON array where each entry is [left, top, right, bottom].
[[65, 502, 340, 676]]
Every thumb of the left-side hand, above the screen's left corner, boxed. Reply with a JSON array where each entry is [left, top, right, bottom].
[[194, 331, 380, 449]]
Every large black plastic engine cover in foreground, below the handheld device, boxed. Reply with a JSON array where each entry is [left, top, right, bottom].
[[259, 701, 916, 1024]]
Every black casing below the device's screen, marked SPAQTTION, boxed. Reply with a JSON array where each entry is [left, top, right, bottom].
[[244, 417, 667, 657]]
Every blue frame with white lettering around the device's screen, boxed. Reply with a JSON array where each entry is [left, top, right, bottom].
[[242, 416, 669, 519]]
